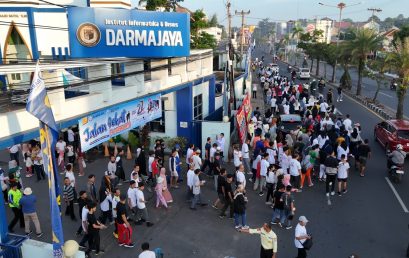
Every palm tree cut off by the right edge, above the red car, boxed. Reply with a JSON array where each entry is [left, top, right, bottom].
[[387, 37, 409, 119]]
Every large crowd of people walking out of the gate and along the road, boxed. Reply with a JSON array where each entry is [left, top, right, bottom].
[[0, 55, 371, 258]]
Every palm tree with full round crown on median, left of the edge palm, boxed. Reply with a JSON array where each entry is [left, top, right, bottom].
[[349, 28, 383, 95]]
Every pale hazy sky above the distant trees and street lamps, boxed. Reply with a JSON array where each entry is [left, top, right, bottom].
[[180, 0, 409, 26]]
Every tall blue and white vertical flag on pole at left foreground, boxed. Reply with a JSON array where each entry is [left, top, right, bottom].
[[26, 64, 64, 258]]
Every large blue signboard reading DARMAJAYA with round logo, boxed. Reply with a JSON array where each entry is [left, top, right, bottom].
[[68, 7, 190, 58]]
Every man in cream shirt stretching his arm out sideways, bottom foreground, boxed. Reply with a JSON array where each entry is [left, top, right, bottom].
[[239, 223, 277, 258]]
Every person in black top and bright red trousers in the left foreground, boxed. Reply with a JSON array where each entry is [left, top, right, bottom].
[[116, 194, 134, 248]]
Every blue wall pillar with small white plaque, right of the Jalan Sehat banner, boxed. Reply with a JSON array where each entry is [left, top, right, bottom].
[[176, 84, 194, 143]]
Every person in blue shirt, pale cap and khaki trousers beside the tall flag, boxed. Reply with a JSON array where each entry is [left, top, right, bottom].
[[19, 187, 43, 237]]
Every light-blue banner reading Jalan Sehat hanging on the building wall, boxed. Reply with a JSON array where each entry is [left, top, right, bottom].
[[78, 94, 162, 151]]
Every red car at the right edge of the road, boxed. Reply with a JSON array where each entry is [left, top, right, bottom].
[[374, 120, 409, 152]]
